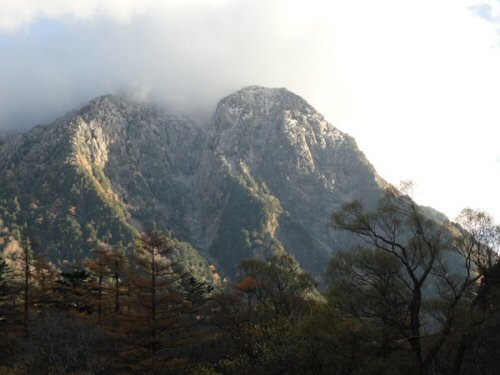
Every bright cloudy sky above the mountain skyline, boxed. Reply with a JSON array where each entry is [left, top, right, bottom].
[[0, 0, 500, 222]]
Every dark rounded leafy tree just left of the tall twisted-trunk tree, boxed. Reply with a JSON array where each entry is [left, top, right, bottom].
[[326, 247, 411, 359]]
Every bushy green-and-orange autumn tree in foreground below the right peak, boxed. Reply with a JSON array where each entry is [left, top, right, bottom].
[[212, 256, 317, 374]]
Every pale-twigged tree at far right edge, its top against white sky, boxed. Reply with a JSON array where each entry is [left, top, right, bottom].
[[452, 208, 500, 374]]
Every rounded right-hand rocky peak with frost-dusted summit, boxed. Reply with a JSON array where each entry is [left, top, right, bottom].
[[199, 86, 386, 274]]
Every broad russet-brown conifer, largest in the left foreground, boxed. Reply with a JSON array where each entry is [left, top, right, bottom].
[[120, 229, 189, 373]]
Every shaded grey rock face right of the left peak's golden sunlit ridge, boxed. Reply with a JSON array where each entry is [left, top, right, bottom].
[[74, 96, 206, 242]]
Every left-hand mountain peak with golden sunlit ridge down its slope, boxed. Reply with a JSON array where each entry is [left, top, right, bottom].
[[0, 96, 217, 280]]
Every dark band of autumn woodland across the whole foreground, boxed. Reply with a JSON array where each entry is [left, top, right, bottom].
[[0, 190, 500, 375]]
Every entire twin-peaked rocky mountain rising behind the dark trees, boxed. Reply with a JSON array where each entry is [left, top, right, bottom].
[[0, 86, 394, 277]]
